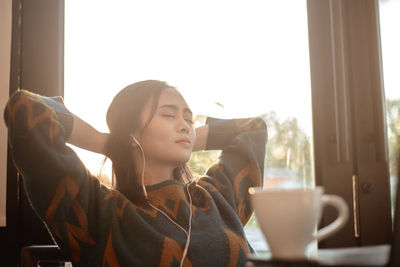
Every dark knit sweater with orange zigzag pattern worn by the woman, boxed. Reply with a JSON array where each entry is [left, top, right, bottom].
[[4, 90, 267, 266]]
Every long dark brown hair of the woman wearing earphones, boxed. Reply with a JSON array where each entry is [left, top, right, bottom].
[[105, 80, 192, 204]]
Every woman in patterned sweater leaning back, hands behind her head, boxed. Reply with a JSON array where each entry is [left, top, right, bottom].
[[4, 80, 266, 266]]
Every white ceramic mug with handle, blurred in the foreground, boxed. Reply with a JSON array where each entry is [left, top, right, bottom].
[[250, 186, 349, 259]]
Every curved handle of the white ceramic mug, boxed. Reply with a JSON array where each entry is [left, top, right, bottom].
[[315, 195, 349, 241]]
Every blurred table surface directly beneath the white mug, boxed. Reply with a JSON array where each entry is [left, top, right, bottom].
[[246, 245, 390, 267]]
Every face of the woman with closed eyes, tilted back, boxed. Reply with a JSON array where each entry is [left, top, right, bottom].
[[135, 88, 196, 167]]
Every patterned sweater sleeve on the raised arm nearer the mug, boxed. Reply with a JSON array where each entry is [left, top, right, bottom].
[[204, 118, 267, 225]]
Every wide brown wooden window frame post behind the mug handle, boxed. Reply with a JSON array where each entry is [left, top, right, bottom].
[[308, 0, 392, 247]]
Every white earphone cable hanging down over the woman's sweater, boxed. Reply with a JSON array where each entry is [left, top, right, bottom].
[[131, 135, 193, 267]]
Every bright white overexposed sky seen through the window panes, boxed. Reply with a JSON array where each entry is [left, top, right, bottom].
[[65, 0, 400, 176]]
